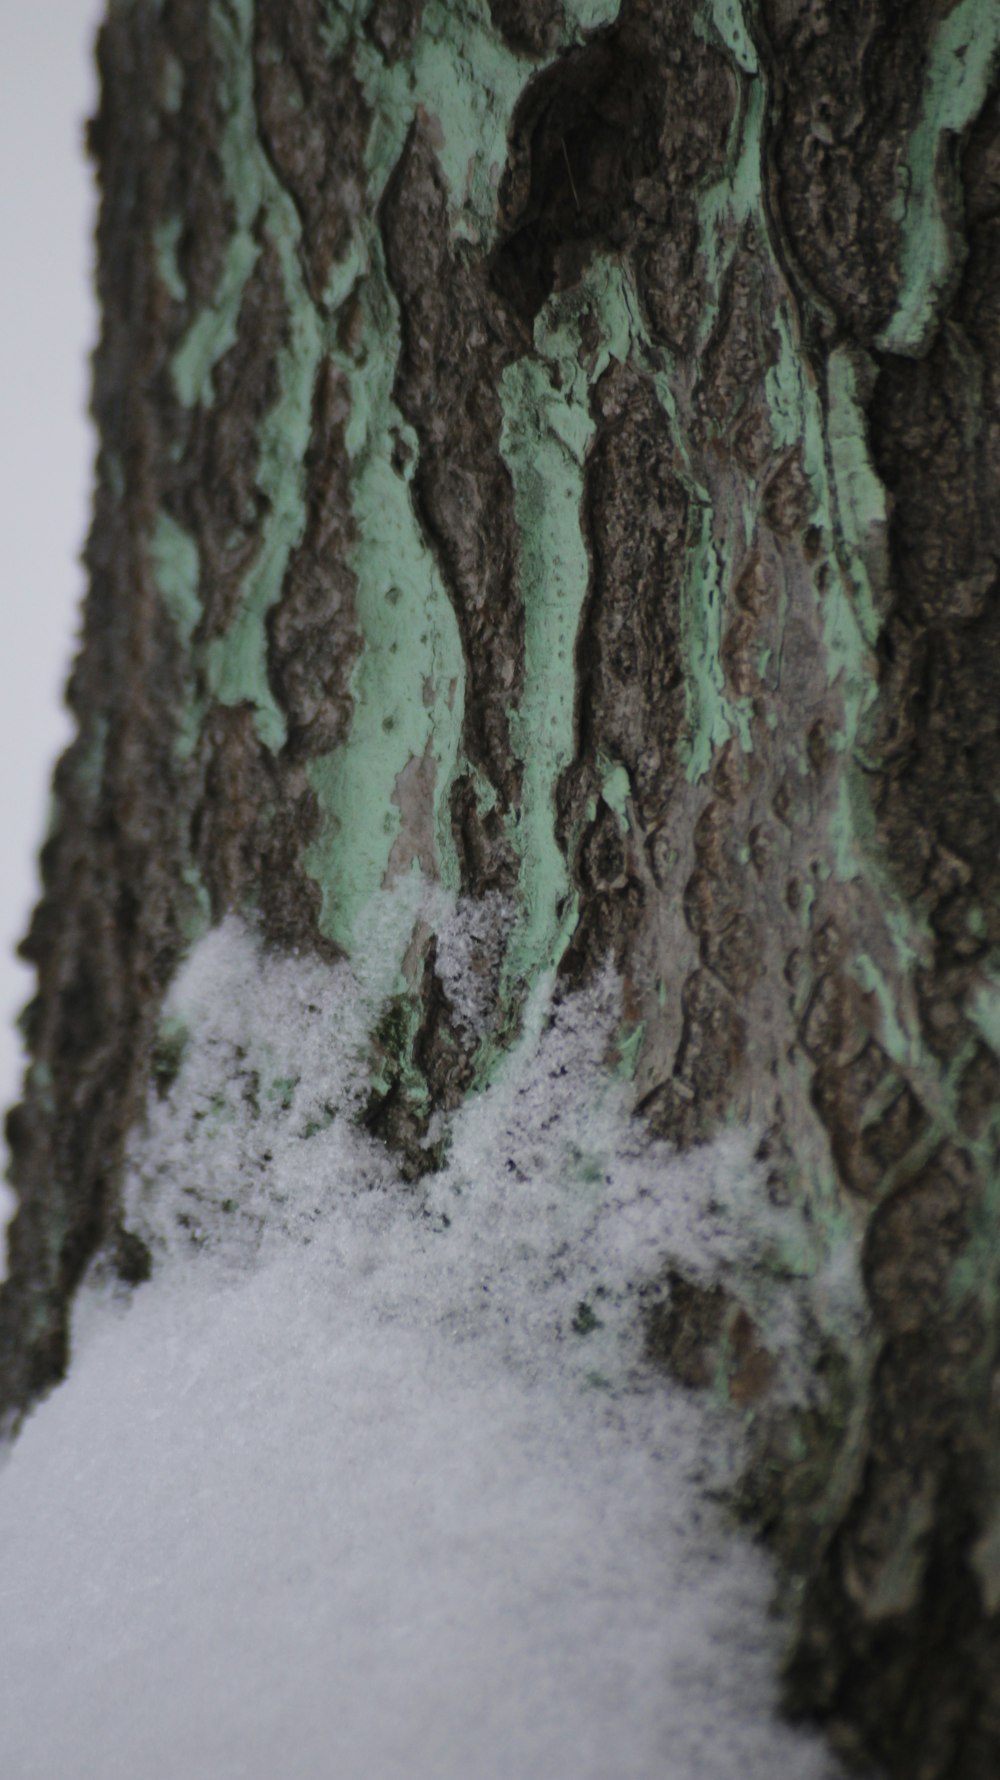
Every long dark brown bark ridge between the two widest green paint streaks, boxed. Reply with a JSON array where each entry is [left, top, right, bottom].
[[379, 119, 525, 895]]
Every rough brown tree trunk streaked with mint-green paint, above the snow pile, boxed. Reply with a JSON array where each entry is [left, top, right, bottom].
[[0, 0, 1000, 1780]]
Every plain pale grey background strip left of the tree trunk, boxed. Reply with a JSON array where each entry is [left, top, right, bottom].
[[0, 0, 101, 1224]]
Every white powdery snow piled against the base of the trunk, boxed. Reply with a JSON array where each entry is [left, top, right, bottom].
[[0, 897, 836, 1780]]
